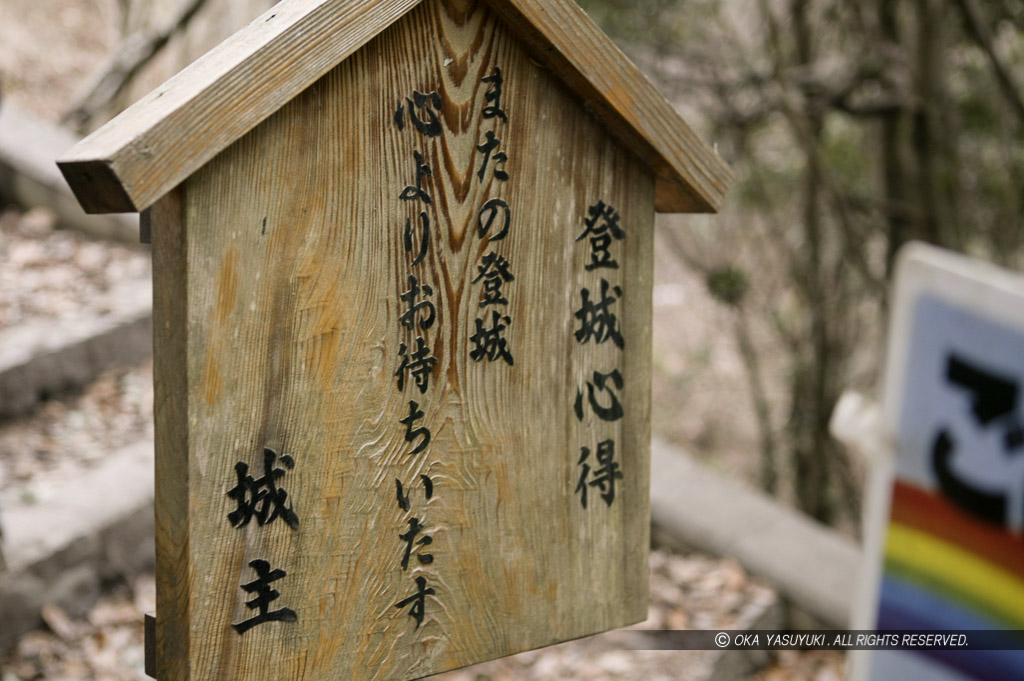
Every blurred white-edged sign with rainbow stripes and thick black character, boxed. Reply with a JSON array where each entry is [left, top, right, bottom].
[[853, 244, 1024, 681]]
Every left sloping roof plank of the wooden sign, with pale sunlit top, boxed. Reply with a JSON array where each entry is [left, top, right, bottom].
[[57, 0, 420, 213]]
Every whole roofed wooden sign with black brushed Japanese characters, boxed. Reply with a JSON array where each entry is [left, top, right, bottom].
[[61, 0, 728, 681]]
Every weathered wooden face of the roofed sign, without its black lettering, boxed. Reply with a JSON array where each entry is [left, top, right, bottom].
[[153, 0, 654, 681]]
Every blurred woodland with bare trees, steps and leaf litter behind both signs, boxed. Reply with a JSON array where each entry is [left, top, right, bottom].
[[0, 0, 1024, 681]]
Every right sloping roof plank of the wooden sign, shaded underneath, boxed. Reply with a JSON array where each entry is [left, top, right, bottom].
[[488, 0, 732, 213]]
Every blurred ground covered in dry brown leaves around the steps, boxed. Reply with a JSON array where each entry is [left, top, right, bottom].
[[0, 0, 843, 681]]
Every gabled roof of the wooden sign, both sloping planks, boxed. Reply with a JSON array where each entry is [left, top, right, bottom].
[[57, 0, 731, 213]]
